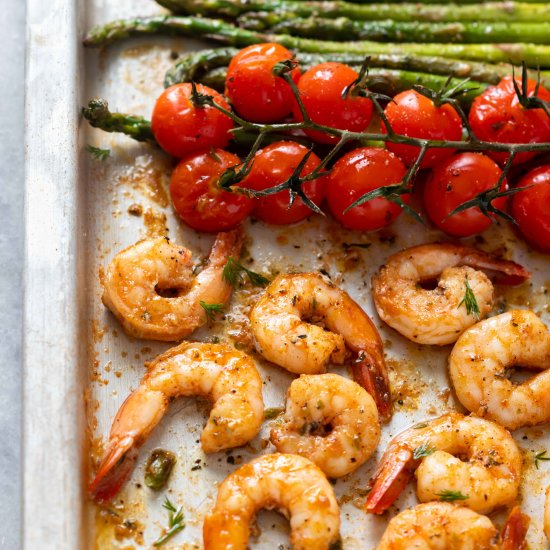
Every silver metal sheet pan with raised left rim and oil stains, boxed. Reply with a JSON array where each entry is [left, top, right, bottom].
[[24, 0, 550, 550]]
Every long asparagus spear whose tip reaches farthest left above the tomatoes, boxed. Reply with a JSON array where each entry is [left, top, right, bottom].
[[84, 16, 550, 68]]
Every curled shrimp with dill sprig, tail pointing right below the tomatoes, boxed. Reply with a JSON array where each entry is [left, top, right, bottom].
[[372, 244, 529, 346]]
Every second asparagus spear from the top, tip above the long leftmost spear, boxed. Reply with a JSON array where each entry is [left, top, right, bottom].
[[242, 12, 550, 45]]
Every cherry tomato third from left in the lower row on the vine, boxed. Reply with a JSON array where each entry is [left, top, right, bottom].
[[327, 147, 408, 231]]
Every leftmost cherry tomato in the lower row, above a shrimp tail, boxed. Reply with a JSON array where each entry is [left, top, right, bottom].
[[170, 149, 254, 233]]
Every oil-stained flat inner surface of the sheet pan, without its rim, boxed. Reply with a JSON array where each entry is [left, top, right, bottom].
[[25, 0, 550, 550]]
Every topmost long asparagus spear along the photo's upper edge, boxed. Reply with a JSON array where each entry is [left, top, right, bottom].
[[156, 0, 550, 23]]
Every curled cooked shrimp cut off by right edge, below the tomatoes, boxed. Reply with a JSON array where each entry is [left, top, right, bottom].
[[449, 310, 550, 430]]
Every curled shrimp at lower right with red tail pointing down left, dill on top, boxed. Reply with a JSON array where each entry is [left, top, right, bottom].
[[366, 413, 522, 514]]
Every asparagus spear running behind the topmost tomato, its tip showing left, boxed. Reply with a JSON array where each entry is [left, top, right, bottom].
[[165, 48, 550, 89]]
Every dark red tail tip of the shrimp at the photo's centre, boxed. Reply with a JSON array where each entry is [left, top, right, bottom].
[[353, 351, 392, 422]]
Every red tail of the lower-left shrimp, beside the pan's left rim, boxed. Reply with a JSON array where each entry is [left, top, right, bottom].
[[89, 437, 138, 502]]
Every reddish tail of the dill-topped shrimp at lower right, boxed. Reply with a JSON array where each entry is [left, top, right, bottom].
[[365, 448, 414, 514]]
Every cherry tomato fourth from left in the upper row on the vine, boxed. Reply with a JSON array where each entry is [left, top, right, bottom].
[[382, 90, 462, 168]]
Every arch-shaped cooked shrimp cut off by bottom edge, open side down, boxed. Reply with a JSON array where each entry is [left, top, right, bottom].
[[203, 453, 340, 550]]
